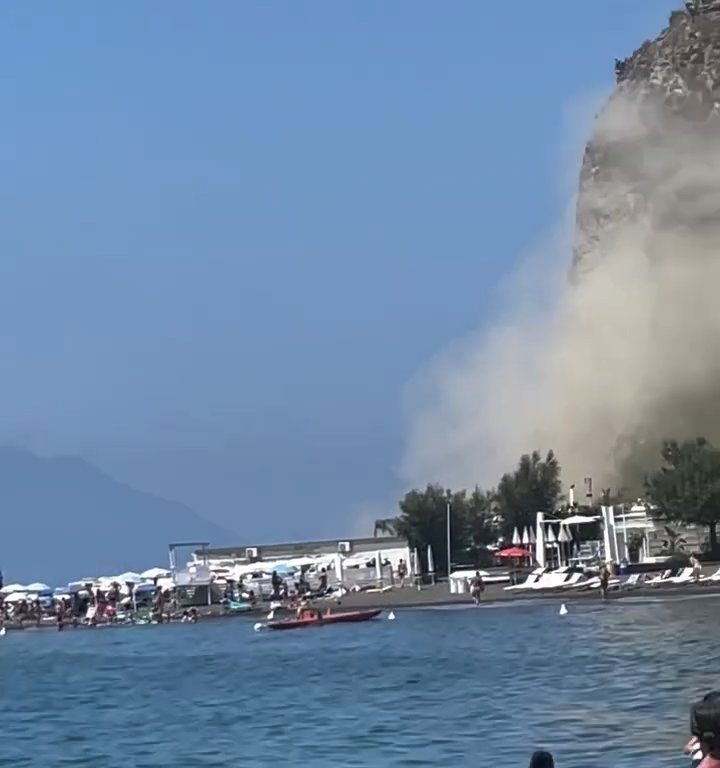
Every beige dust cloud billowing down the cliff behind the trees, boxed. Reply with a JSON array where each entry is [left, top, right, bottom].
[[402, 93, 720, 493]]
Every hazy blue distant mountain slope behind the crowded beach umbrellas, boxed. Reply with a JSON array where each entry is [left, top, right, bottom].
[[0, 448, 237, 585]]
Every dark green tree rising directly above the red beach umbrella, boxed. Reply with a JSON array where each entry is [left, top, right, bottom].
[[496, 451, 560, 537]]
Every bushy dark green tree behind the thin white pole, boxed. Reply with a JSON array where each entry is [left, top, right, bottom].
[[395, 485, 468, 573]]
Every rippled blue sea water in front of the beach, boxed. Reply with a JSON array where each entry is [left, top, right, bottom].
[[0, 598, 720, 768]]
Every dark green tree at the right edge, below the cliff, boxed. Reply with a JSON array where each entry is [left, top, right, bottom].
[[647, 437, 720, 552]]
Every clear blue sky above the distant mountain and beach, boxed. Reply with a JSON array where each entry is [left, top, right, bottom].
[[0, 0, 679, 543]]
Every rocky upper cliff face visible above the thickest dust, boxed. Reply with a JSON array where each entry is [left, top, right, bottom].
[[572, 0, 720, 279]]
